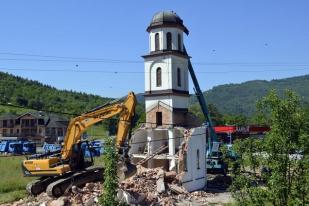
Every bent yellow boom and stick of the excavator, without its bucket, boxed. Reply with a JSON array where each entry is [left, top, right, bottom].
[[61, 92, 136, 160]]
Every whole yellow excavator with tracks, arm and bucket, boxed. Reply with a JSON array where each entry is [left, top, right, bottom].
[[22, 92, 136, 197]]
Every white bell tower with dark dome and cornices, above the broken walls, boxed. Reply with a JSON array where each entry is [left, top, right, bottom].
[[143, 11, 189, 127]]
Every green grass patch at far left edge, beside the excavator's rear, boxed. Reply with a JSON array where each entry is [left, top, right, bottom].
[[0, 156, 34, 204]]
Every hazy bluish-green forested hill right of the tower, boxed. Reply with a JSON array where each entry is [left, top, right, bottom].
[[191, 75, 309, 116]]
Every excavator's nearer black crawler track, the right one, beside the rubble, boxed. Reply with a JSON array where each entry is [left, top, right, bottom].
[[46, 167, 103, 197]]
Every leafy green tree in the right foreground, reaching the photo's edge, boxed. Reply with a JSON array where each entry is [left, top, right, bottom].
[[231, 91, 309, 205]]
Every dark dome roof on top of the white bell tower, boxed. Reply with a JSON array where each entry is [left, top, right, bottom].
[[147, 11, 189, 34]]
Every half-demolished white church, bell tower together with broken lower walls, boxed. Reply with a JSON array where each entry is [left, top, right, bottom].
[[129, 11, 207, 192]]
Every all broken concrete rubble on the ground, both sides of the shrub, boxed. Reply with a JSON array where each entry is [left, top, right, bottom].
[[1, 166, 230, 206]]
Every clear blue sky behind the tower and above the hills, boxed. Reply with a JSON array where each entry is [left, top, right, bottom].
[[0, 0, 309, 97]]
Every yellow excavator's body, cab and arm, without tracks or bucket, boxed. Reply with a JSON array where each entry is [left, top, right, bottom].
[[22, 92, 136, 176]]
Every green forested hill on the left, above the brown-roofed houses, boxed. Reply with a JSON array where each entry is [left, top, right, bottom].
[[0, 72, 112, 114]]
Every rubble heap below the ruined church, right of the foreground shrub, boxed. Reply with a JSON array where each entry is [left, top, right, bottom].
[[118, 167, 211, 205]]
